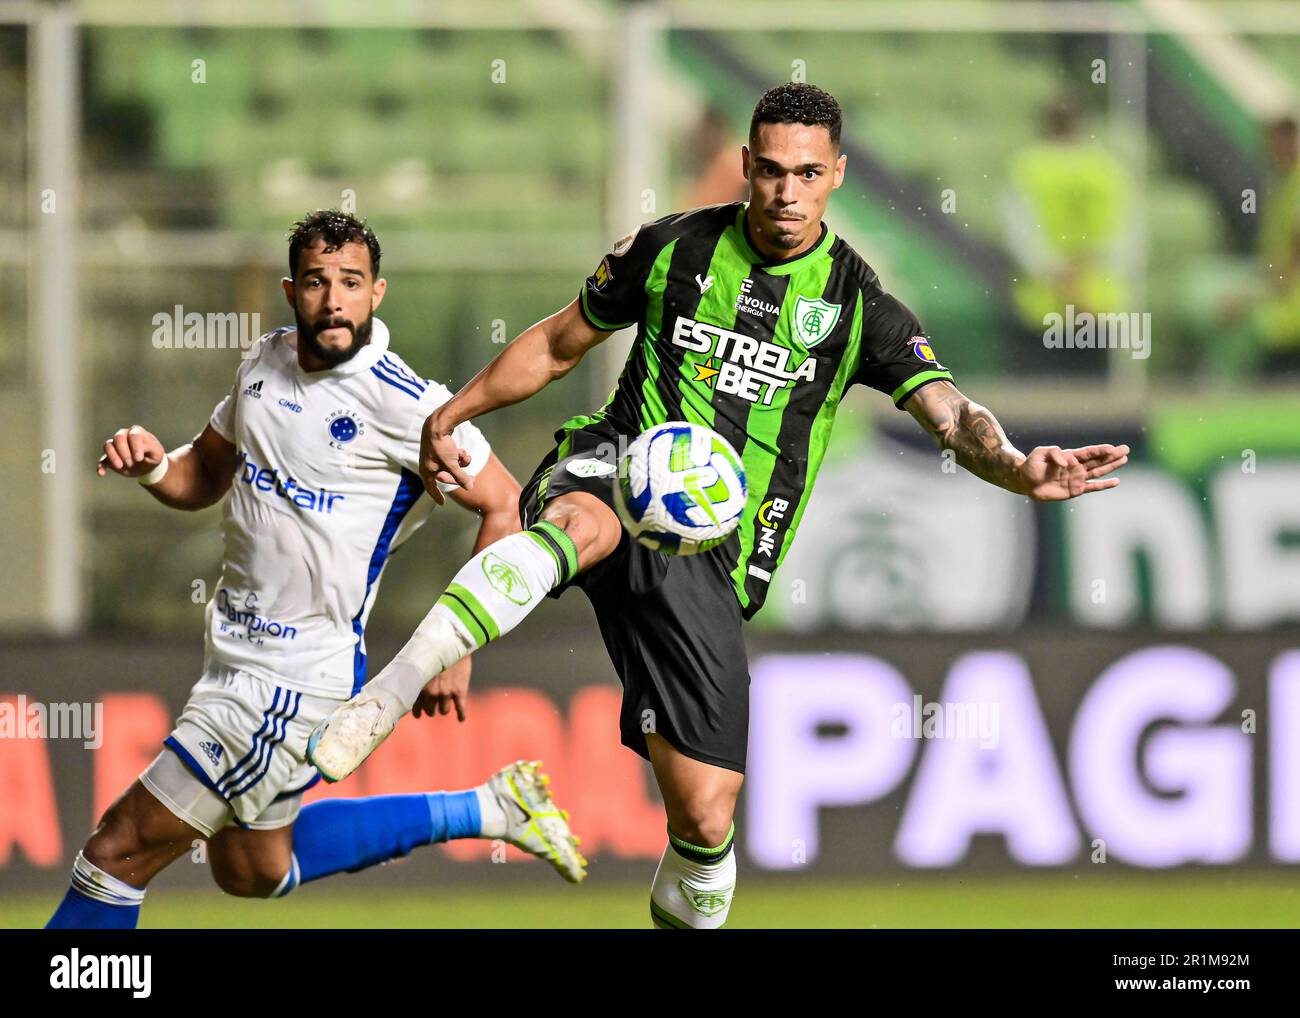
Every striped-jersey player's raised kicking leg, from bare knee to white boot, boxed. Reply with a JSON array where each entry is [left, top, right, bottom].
[[307, 491, 623, 781]]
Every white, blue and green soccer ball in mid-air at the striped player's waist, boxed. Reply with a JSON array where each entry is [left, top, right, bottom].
[[614, 421, 746, 555]]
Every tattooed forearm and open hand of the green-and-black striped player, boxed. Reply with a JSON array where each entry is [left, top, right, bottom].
[[905, 381, 1128, 502]]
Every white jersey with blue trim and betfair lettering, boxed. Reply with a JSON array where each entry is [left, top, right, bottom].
[[205, 319, 491, 699]]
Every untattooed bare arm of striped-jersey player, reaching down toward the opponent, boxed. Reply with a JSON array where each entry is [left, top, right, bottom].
[[420, 299, 611, 503]]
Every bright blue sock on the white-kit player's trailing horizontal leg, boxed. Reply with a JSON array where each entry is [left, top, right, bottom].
[[286, 790, 482, 893]]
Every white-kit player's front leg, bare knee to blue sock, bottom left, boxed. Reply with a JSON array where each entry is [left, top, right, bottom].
[[46, 781, 207, 930]]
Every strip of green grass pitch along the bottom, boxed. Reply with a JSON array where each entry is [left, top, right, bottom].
[[0, 871, 1300, 930]]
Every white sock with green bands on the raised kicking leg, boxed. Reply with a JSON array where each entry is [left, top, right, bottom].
[[368, 520, 577, 710]]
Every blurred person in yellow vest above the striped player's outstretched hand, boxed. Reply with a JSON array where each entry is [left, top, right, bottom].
[[1005, 96, 1135, 373]]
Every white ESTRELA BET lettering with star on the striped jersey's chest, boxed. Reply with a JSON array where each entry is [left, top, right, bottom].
[[672, 319, 816, 407]]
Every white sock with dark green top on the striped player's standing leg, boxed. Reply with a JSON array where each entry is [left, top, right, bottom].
[[650, 826, 736, 930]]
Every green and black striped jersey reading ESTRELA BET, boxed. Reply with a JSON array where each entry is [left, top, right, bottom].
[[563, 203, 952, 619]]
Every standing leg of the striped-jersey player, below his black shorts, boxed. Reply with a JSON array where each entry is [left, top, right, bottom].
[[646, 735, 745, 930]]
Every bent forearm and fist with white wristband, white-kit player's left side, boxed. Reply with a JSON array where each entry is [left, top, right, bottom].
[[96, 424, 239, 510]]
